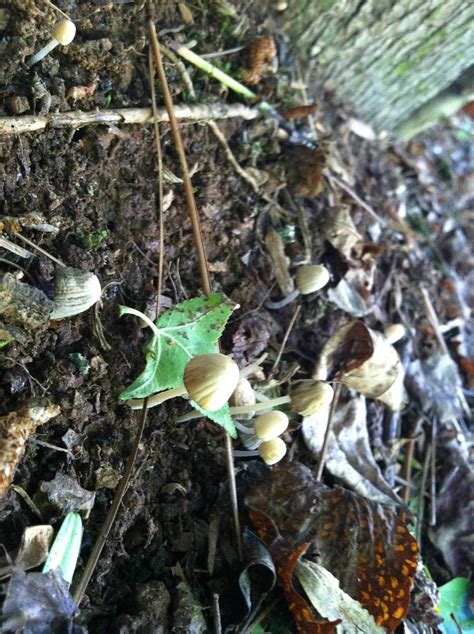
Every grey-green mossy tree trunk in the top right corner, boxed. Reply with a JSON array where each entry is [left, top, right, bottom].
[[285, 0, 474, 131]]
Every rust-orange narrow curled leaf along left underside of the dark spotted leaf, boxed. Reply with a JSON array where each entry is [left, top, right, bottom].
[[250, 509, 340, 634]]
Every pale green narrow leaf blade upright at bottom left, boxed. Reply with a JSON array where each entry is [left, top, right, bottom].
[[41, 512, 83, 585]]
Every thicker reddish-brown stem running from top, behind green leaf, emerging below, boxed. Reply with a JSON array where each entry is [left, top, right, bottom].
[[147, 7, 243, 560]]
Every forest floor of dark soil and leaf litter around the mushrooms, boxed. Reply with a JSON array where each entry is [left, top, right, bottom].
[[0, 0, 474, 633]]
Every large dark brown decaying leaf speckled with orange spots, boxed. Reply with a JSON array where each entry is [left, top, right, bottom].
[[247, 462, 418, 632]]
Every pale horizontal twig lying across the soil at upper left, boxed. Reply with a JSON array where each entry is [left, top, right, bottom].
[[0, 103, 259, 136]]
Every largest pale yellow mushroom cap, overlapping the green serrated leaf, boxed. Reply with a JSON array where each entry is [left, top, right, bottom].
[[184, 353, 240, 412]]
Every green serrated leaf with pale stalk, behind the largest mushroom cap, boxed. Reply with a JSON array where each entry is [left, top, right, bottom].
[[119, 293, 233, 398]]
